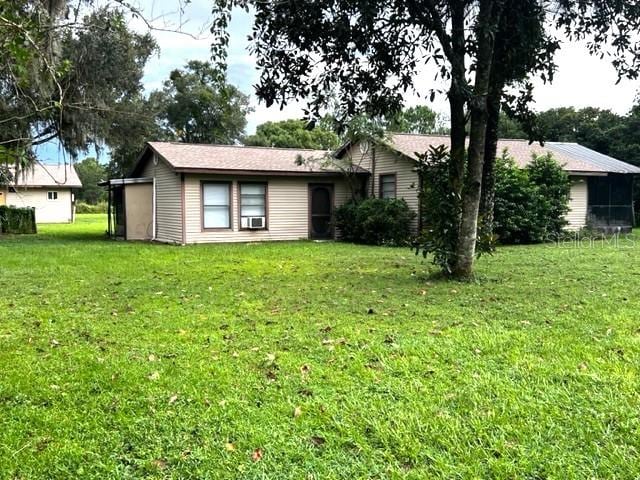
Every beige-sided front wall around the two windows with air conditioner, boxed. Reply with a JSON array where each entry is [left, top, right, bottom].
[[185, 175, 350, 243]]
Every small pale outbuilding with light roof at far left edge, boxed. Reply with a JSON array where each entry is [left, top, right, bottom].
[[0, 163, 82, 223]]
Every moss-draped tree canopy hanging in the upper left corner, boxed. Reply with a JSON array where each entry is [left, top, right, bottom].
[[0, 1, 157, 167]]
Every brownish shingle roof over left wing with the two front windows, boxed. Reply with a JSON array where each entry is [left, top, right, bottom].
[[133, 142, 365, 175]]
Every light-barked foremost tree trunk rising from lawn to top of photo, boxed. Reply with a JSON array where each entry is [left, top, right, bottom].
[[453, 0, 500, 278]]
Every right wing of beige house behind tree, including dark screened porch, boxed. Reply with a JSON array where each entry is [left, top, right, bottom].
[[336, 133, 640, 230]]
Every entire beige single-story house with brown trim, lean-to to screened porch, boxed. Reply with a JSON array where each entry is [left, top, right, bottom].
[[103, 134, 640, 244]]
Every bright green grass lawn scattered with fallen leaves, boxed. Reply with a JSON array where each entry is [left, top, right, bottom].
[[0, 215, 640, 479]]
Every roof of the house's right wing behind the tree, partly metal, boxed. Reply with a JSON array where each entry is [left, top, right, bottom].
[[380, 133, 640, 173]]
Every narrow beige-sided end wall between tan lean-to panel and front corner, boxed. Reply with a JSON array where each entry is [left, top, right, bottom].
[[140, 158, 182, 243]]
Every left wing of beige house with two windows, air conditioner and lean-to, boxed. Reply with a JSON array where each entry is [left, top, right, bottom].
[[104, 142, 368, 244]]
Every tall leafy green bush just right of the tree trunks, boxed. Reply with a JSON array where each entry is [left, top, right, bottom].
[[494, 155, 571, 244]]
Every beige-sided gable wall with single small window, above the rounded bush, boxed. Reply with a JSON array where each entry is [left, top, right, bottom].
[[348, 145, 419, 231]]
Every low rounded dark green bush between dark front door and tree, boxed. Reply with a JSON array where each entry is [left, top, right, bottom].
[[335, 198, 416, 246]]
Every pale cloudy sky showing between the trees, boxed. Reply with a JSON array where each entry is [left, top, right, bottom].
[[38, 0, 640, 162]]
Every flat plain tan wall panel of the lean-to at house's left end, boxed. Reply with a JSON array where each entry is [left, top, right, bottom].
[[124, 183, 153, 240]]
